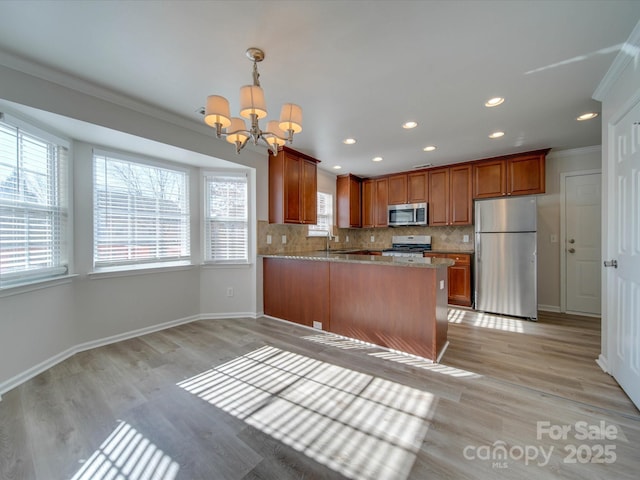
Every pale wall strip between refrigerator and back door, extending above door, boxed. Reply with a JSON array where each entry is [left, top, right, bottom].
[[538, 145, 601, 311]]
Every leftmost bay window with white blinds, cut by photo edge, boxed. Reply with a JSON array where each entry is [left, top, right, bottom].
[[0, 113, 69, 288]]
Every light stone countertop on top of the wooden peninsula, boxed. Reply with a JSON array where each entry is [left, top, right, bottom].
[[258, 250, 455, 268]]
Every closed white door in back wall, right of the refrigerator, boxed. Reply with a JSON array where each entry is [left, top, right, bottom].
[[564, 172, 602, 315]]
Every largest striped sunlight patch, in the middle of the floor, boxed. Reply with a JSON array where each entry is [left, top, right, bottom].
[[178, 346, 434, 480]]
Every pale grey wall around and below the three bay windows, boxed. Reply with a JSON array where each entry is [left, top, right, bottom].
[[0, 65, 268, 394]]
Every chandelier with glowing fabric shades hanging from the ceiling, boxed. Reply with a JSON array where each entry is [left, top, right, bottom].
[[204, 48, 302, 155]]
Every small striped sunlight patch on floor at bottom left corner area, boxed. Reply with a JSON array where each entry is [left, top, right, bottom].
[[71, 422, 180, 480]]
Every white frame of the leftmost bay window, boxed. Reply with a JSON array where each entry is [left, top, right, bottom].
[[0, 112, 74, 292]]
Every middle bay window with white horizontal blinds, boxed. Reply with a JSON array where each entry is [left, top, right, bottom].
[[93, 151, 190, 268]]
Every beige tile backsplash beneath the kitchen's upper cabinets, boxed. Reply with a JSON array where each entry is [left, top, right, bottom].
[[258, 220, 474, 254]]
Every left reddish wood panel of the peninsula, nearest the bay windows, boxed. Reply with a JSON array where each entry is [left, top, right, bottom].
[[263, 258, 330, 330]]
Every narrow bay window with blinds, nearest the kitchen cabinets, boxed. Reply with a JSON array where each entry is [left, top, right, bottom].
[[204, 173, 249, 263]]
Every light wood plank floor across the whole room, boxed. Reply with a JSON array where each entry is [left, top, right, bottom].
[[0, 309, 640, 480]]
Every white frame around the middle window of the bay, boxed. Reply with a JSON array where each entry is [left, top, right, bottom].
[[90, 147, 194, 275]]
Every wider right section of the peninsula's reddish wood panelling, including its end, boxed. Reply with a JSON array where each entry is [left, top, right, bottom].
[[330, 262, 447, 360]]
